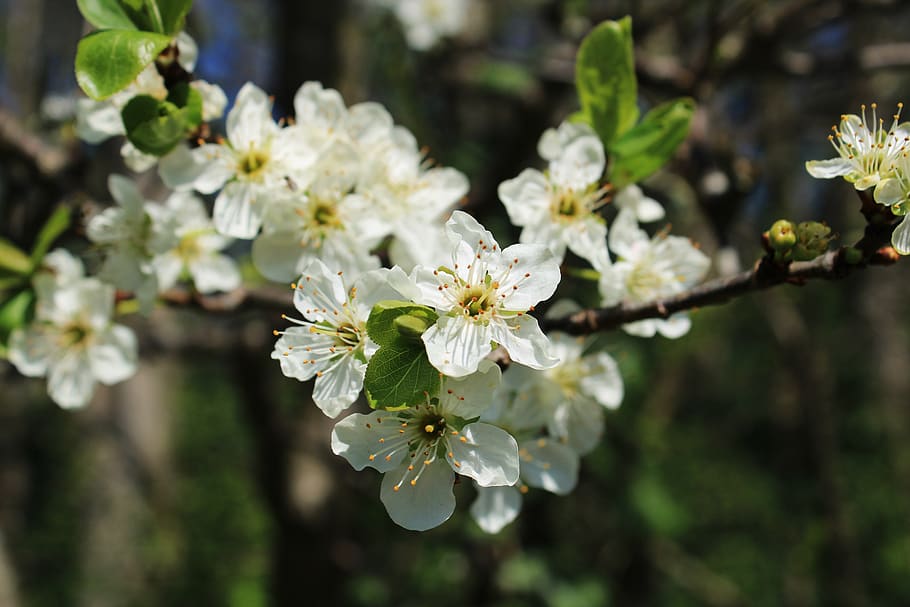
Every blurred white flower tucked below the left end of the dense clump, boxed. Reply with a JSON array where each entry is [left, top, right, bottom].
[[152, 192, 241, 293]]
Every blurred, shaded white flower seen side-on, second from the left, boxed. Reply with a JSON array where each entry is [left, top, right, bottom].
[[86, 175, 178, 313]]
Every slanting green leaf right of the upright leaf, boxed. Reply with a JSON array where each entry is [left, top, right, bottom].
[[609, 97, 695, 189]]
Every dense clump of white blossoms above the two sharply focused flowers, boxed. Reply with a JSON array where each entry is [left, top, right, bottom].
[[159, 82, 468, 281]]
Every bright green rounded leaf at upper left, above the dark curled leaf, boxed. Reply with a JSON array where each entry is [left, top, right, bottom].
[[76, 30, 171, 100]]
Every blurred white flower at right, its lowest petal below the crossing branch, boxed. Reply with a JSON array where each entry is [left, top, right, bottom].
[[599, 209, 711, 338]]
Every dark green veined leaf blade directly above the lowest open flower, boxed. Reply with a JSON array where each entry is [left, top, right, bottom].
[[363, 340, 439, 409]]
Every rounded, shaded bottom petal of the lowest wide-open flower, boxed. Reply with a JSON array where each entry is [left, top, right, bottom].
[[379, 460, 455, 531]]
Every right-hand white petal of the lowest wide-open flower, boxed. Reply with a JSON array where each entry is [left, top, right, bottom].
[[446, 422, 519, 487]]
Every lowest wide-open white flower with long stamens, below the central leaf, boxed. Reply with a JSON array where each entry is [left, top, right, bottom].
[[332, 361, 519, 531]]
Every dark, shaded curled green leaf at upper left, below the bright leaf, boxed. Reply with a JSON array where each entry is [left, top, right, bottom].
[[121, 83, 202, 156]]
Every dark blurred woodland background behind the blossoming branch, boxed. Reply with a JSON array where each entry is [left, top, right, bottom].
[[0, 0, 910, 607]]
